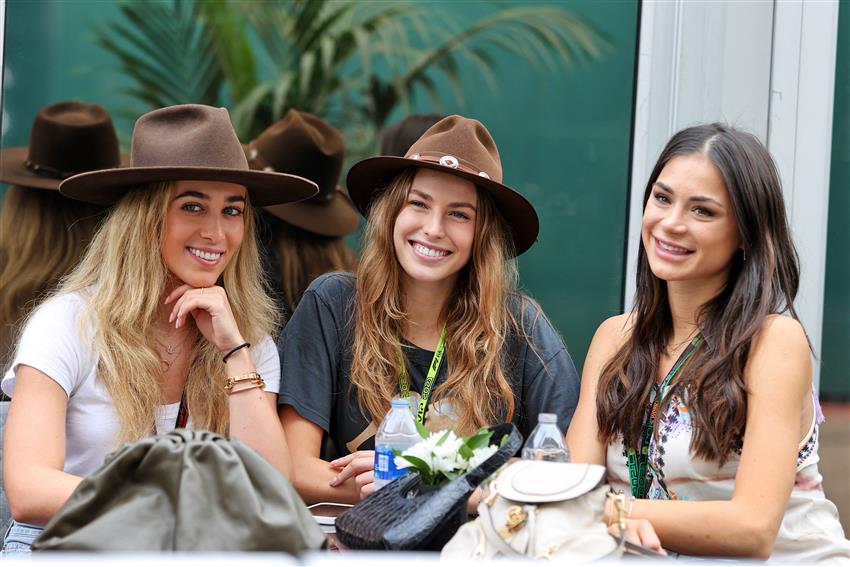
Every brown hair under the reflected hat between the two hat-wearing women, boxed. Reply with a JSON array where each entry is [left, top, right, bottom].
[[255, 212, 357, 316]]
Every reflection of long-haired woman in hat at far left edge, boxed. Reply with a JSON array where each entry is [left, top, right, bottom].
[[0, 101, 121, 370]]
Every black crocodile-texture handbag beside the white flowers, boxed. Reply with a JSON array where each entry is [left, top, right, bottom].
[[336, 423, 522, 551]]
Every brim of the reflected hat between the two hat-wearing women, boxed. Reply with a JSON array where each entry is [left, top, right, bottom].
[[266, 188, 360, 237]]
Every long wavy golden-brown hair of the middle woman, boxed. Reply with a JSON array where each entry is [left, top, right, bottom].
[[351, 169, 522, 434]]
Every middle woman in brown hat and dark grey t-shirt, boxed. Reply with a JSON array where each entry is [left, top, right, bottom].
[[278, 116, 578, 502]]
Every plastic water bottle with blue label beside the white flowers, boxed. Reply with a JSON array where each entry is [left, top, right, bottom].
[[375, 398, 422, 489]]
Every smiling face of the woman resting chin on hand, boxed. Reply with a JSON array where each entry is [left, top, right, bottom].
[[161, 181, 247, 288]]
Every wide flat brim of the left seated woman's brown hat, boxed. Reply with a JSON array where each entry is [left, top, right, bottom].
[[59, 167, 319, 207]]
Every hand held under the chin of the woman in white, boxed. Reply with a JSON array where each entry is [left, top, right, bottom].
[[165, 284, 245, 352]]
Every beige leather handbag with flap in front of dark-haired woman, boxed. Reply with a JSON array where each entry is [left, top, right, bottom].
[[441, 461, 624, 563]]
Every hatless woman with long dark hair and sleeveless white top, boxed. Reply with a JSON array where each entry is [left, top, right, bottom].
[[567, 124, 850, 562]]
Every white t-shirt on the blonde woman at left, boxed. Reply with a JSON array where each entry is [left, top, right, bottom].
[[0, 293, 280, 476]]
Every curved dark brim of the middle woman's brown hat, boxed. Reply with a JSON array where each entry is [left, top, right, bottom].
[[347, 156, 540, 256]]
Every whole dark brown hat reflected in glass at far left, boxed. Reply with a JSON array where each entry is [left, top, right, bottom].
[[0, 100, 126, 190]]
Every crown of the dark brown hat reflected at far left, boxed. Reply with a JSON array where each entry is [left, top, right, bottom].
[[27, 100, 121, 178]]
